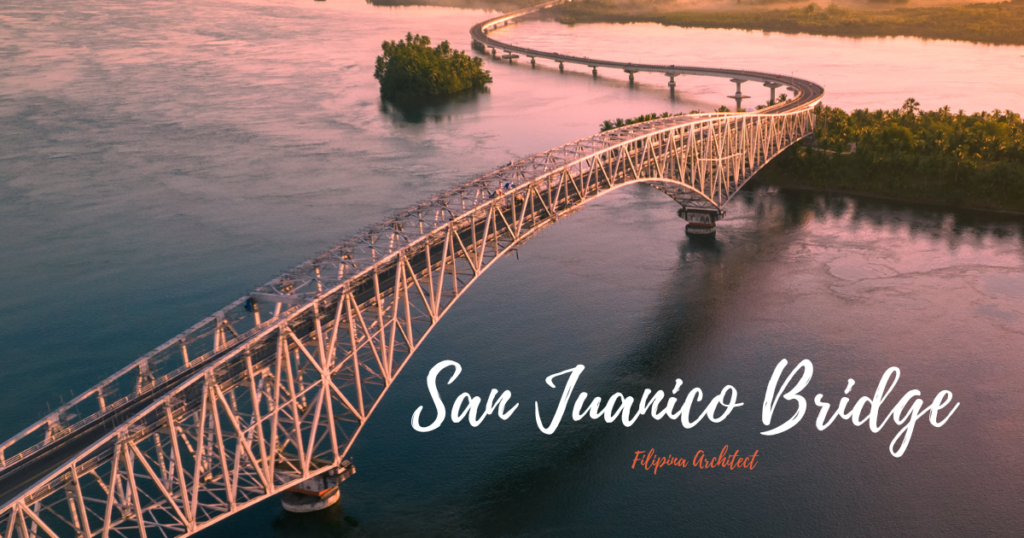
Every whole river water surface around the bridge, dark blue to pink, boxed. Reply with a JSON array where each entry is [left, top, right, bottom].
[[0, 0, 1024, 537]]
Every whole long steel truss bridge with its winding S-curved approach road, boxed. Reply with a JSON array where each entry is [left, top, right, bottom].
[[0, 3, 823, 538]]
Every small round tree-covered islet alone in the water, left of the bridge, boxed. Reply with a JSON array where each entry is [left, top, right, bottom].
[[374, 34, 492, 100]]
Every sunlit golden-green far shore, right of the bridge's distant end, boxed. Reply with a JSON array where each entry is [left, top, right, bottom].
[[560, 0, 1024, 45]]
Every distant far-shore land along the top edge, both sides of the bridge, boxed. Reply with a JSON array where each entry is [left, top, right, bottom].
[[368, 0, 1024, 45]]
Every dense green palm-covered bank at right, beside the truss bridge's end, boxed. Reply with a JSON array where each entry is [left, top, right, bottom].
[[757, 98, 1024, 212]]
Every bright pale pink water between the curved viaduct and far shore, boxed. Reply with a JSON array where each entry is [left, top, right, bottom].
[[495, 22, 1024, 112]]
